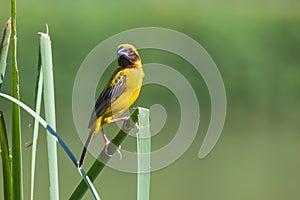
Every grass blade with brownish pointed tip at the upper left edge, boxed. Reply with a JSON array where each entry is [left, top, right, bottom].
[[0, 19, 11, 91]]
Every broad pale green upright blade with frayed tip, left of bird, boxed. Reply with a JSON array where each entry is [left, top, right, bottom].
[[39, 28, 59, 200]]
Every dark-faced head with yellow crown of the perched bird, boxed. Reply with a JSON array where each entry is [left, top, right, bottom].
[[117, 44, 142, 68]]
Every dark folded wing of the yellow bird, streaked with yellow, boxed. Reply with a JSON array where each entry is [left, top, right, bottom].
[[88, 69, 126, 128]]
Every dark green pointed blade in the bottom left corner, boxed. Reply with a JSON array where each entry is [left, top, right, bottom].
[[0, 111, 13, 200]]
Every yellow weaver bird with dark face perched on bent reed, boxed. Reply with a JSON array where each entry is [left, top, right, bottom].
[[79, 44, 144, 167]]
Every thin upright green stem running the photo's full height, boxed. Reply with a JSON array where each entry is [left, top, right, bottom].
[[11, 0, 23, 200]]
